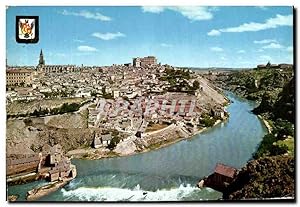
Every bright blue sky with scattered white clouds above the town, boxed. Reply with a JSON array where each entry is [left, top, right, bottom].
[[6, 6, 293, 68]]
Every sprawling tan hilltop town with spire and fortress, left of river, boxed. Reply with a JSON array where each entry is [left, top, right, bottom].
[[6, 51, 228, 189]]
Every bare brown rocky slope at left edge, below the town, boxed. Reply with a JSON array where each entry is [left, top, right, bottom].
[[6, 113, 93, 154]]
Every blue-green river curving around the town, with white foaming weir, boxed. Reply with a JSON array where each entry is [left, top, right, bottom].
[[8, 93, 267, 201]]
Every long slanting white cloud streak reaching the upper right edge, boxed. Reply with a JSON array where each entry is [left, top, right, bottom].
[[207, 14, 293, 35]]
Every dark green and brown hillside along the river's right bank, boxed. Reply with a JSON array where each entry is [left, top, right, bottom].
[[220, 64, 295, 199]]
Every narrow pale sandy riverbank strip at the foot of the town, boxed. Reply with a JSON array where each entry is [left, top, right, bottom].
[[67, 118, 227, 160]]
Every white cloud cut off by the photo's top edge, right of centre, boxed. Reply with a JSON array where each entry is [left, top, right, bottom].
[[142, 6, 217, 21]]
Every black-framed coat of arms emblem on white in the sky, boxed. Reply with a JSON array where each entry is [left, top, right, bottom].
[[16, 16, 38, 43]]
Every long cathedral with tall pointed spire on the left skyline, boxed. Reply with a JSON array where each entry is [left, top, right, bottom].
[[37, 50, 80, 73]]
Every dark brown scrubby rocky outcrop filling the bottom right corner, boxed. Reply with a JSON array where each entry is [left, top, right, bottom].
[[223, 155, 295, 200]]
